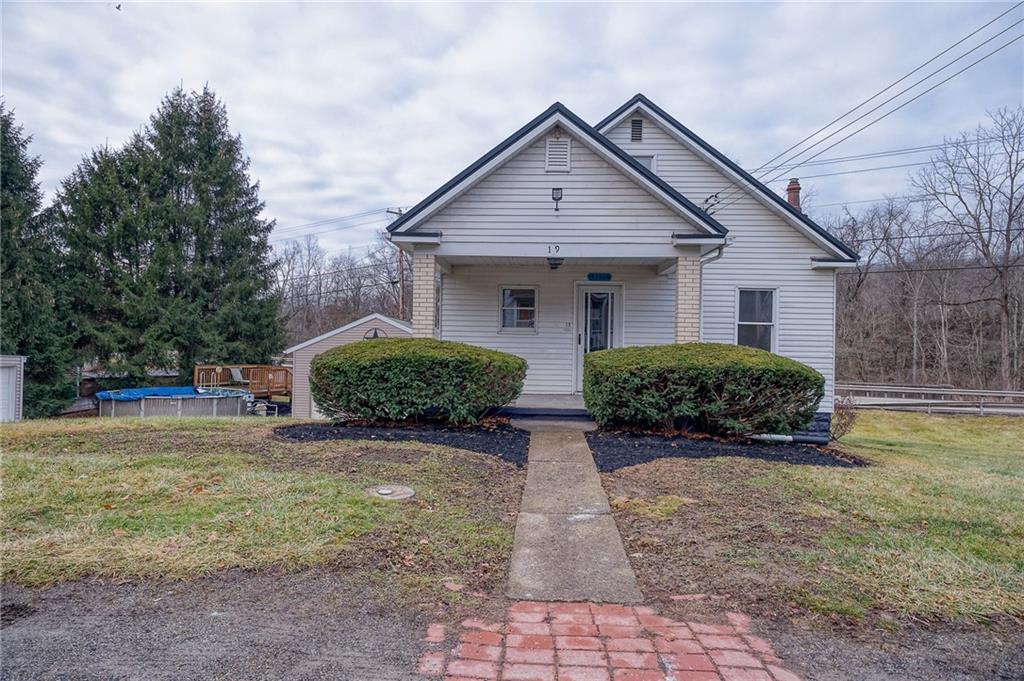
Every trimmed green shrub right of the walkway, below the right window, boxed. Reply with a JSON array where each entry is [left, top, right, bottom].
[[583, 343, 825, 433]]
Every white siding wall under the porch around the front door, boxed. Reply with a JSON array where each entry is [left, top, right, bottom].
[[442, 263, 676, 394]]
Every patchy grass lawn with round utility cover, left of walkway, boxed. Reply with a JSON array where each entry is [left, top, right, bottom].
[[0, 418, 524, 600]]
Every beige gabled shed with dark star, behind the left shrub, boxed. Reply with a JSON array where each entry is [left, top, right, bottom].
[[285, 312, 413, 419]]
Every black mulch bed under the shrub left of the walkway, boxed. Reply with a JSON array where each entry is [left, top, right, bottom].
[[274, 423, 529, 468]]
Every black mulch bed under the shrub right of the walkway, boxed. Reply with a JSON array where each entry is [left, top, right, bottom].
[[587, 430, 864, 473]]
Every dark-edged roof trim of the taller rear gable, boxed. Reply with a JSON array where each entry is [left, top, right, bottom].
[[595, 93, 860, 262]]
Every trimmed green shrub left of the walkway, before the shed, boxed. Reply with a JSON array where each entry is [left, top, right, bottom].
[[309, 338, 526, 423]]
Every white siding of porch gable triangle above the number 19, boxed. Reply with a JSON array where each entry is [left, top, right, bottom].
[[418, 130, 700, 244]]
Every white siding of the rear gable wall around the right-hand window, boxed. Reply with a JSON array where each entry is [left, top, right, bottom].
[[607, 116, 836, 412]]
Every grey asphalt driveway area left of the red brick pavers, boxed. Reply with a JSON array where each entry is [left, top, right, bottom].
[[2, 570, 427, 681]]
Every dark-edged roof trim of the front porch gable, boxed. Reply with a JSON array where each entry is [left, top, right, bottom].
[[387, 101, 729, 237]]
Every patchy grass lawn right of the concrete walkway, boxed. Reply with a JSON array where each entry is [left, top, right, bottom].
[[604, 412, 1024, 622]]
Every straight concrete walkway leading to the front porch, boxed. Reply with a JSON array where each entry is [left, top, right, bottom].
[[508, 420, 642, 603]]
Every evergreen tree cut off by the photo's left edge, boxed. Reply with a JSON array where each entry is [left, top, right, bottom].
[[0, 102, 75, 417]]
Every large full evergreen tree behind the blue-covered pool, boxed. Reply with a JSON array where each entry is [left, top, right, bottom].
[[59, 88, 284, 381]]
